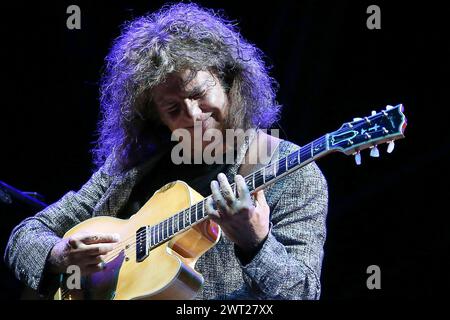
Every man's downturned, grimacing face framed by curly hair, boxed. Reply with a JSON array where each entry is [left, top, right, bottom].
[[153, 71, 228, 148]]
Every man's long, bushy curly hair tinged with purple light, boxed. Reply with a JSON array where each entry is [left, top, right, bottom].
[[92, 3, 280, 172]]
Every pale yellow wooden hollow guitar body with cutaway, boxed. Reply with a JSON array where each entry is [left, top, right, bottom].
[[55, 181, 221, 300]]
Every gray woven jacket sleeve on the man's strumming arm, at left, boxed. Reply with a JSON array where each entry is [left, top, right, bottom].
[[4, 160, 111, 292]]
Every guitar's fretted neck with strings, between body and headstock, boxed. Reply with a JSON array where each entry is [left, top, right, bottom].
[[137, 135, 330, 251]]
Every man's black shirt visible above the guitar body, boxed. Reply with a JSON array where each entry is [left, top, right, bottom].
[[118, 151, 227, 219]]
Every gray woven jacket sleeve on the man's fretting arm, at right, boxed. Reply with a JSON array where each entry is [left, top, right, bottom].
[[235, 163, 328, 300]]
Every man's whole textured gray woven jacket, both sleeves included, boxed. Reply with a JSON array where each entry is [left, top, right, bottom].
[[5, 141, 328, 299]]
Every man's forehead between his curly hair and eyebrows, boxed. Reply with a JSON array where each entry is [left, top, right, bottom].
[[152, 71, 218, 103]]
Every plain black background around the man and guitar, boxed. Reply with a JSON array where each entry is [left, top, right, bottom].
[[0, 0, 450, 300]]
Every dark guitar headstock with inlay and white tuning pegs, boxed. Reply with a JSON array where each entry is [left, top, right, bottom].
[[327, 104, 406, 164]]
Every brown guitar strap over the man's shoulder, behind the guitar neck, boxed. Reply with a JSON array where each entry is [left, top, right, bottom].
[[238, 130, 281, 177]]
